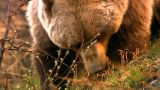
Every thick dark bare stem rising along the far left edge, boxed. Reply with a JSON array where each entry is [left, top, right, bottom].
[[0, 0, 11, 67]]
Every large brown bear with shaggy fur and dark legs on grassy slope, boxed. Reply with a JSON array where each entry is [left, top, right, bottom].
[[27, 0, 158, 90]]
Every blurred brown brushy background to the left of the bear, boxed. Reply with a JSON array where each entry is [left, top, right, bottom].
[[0, 0, 31, 90]]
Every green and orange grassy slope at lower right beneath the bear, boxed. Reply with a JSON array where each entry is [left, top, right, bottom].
[[67, 40, 160, 90]]
